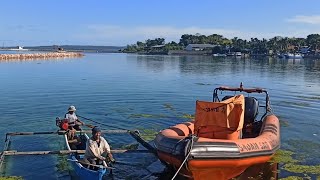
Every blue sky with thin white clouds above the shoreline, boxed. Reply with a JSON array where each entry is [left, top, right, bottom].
[[0, 0, 320, 46]]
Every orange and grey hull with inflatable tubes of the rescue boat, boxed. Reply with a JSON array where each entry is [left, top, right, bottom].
[[155, 115, 280, 179]]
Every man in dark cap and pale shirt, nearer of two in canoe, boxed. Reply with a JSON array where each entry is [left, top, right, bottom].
[[84, 127, 115, 164]]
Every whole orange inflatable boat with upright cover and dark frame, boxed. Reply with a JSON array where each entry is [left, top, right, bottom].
[[155, 84, 280, 180]]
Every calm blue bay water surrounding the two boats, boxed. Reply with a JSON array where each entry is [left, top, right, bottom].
[[0, 54, 320, 179]]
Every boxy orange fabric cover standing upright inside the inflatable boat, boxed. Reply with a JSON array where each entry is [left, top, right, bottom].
[[194, 95, 244, 140]]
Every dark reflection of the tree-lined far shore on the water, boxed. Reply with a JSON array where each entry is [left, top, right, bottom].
[[135, 56, 320, 82]]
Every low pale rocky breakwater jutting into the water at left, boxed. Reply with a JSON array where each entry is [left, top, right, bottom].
[[0, 52, 84, 60]]
